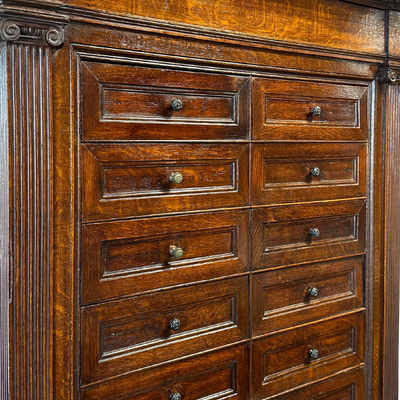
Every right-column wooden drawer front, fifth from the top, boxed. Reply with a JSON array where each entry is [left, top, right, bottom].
[[252, 312, 364, 399]]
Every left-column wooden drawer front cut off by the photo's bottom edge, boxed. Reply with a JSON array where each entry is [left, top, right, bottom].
[[81, 344, 249, 400]]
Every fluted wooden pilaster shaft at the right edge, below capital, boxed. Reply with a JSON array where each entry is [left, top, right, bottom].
[[380, 77, 400, 399]]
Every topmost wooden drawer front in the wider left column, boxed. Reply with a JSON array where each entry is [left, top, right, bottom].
[[81, 62, 250, 141]]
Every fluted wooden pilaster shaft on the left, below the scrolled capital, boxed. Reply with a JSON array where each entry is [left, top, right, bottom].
[[8, 36, 54, 399]]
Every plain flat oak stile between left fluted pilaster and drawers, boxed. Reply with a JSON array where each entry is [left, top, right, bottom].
[[49, 32, 79, 400]]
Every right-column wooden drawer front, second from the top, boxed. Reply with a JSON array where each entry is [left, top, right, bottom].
[[252, 143, 367, 205]]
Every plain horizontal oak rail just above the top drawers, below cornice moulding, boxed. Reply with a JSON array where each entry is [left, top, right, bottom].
[[66, 26, 376, 79]]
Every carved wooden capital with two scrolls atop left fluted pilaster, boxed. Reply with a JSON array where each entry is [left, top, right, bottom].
[[0, 19, 64, 47]]
